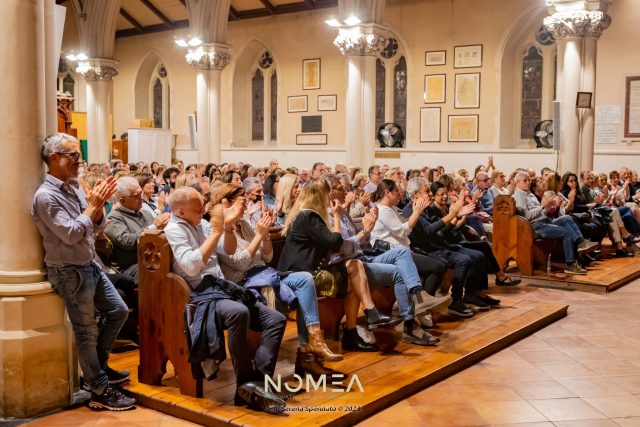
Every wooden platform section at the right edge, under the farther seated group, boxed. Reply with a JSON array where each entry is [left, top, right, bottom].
[[523, 246, 640, 293]]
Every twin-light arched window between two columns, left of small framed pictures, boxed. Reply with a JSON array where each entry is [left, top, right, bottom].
[[251, 50, 278, 144]]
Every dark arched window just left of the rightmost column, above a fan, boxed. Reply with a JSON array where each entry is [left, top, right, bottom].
[[520, 46, 543, 139]]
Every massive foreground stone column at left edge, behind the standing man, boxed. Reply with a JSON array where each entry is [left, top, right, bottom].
[[0, 0, 71, 420]]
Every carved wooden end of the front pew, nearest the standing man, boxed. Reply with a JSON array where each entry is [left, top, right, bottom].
[[138, 230, 202, 397]]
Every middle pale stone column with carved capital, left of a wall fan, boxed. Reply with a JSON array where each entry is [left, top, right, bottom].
[[333, 24, 386, 168]]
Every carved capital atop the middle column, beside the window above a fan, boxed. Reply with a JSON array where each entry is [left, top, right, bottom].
[[333, 24, 387, 56]]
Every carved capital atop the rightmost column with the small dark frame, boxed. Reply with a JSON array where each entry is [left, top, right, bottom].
[[544, 7, 611, 40]]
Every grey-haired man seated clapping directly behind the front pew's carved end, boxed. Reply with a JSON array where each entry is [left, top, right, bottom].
[[104, 176, 171, 284]]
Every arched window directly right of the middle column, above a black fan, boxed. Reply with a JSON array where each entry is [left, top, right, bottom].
[[375, 37, 408, 145]]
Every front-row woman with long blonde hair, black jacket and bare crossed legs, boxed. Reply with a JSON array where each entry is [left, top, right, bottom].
[[278, 178, 402, 351]]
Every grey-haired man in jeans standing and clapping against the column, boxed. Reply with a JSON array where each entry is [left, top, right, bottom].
[[31, 133, 135, 411]]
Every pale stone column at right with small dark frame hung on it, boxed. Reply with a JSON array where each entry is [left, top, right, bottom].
[[544, 0, 611, 173]]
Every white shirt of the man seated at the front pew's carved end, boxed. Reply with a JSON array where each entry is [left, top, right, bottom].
[[164, 214, 225, 289]]
